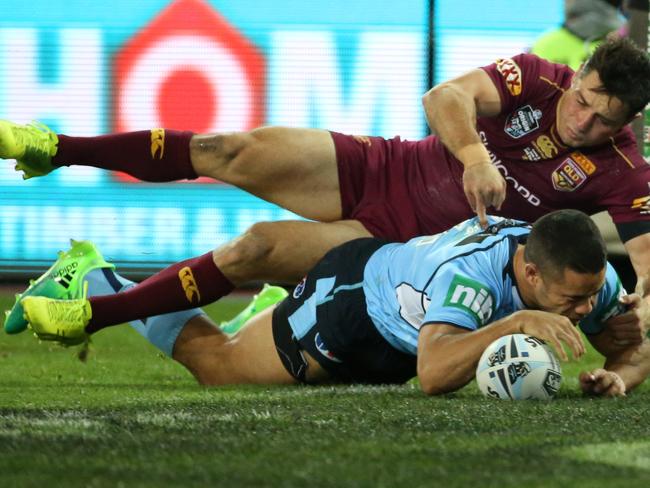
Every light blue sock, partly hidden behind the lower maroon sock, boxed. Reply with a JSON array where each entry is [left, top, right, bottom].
[[85, 268, 204, 357]]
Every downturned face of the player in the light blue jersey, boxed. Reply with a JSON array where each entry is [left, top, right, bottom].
[[535, 268, 605, 323]]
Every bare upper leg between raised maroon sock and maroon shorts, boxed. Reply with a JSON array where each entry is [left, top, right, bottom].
[[190, 127, 341, 222]]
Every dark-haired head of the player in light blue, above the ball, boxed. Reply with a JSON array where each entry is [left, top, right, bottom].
[[524, 210, 607, 321]]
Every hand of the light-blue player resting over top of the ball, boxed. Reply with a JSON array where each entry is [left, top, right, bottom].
[[512, 310, 586, 361]]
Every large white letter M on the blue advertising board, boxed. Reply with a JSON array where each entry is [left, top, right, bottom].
[[269, 31, 425, 138]]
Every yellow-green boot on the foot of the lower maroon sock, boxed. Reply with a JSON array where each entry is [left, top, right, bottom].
[[20, 290, 92, 346]]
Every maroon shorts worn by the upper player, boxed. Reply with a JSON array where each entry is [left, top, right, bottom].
[[331, 132, 422, 241]]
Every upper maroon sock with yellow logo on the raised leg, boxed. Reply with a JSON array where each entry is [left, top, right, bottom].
[[52, 129, 197, 182]]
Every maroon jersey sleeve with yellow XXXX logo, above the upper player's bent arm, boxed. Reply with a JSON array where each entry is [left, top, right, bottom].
[[481, 54, 572, 113]]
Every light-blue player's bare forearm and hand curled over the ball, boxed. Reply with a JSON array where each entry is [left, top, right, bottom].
[[418, 310, 585, 395]]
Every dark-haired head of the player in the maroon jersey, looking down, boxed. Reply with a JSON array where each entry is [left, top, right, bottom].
[[557, 38, 650, 147]]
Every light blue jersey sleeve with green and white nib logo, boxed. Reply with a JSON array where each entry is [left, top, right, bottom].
[[423, 262, 498, 331]]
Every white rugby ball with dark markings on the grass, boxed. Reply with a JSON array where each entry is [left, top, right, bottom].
[[476, 334, 562, 400]]
